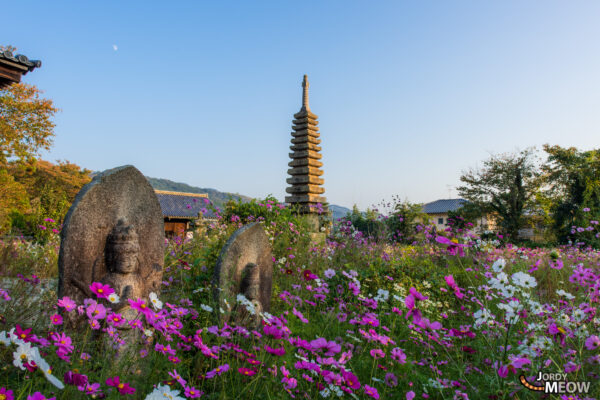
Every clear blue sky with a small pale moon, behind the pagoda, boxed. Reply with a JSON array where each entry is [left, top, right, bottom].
[[0, 1, 600, 208]]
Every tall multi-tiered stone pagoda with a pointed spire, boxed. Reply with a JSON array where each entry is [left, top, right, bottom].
[[285, 75, 327, 214]]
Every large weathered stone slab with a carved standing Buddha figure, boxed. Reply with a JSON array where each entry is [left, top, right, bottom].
[[58, 166, 164, 327]]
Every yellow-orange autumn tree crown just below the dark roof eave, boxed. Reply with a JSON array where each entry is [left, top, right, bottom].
[[0, 83, 58, 168]]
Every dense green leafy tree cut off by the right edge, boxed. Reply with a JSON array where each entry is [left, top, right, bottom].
[[542, 144, 600, 247]]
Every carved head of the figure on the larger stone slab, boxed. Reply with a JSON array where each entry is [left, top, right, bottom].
[[105, 219, 140, 274]]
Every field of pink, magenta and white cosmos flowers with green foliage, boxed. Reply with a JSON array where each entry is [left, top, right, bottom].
[[0, 203, 600, 400]]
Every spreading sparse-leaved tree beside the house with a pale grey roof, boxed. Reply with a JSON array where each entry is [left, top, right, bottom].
[[458, 149, 542, 240]]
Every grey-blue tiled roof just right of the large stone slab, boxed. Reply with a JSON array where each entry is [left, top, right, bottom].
[[155, 190, 212, 219]]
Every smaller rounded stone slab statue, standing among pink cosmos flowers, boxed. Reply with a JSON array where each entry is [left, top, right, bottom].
[[213, 222, 273, 327]]
